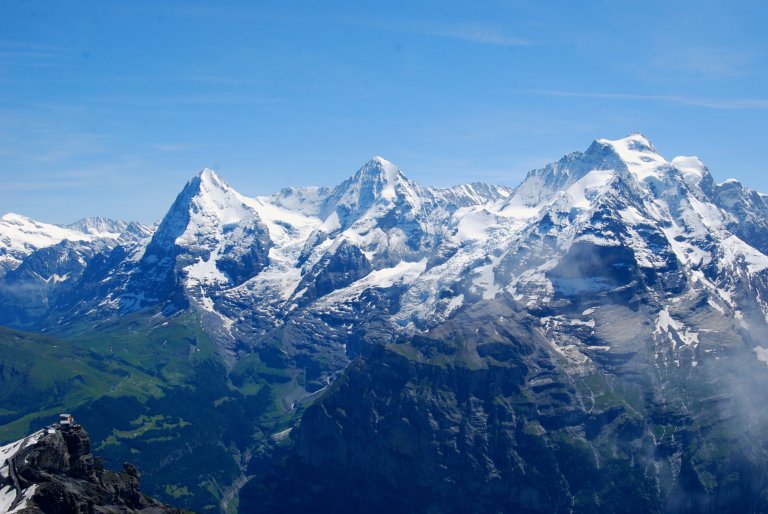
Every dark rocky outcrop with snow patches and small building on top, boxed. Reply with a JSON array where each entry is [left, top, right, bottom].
[[0, 425, 182, 514]]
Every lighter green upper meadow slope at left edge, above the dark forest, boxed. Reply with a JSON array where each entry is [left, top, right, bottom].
[[0, 308, 210, 440]]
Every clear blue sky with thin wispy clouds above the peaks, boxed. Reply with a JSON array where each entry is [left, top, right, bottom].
[[0, 0, 768, 223]]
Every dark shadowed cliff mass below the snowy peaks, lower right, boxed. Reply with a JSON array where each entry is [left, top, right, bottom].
[[240, 296, 768, 514]]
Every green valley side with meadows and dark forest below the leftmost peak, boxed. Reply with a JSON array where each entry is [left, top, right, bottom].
[[0, 311, 301, 512]]
